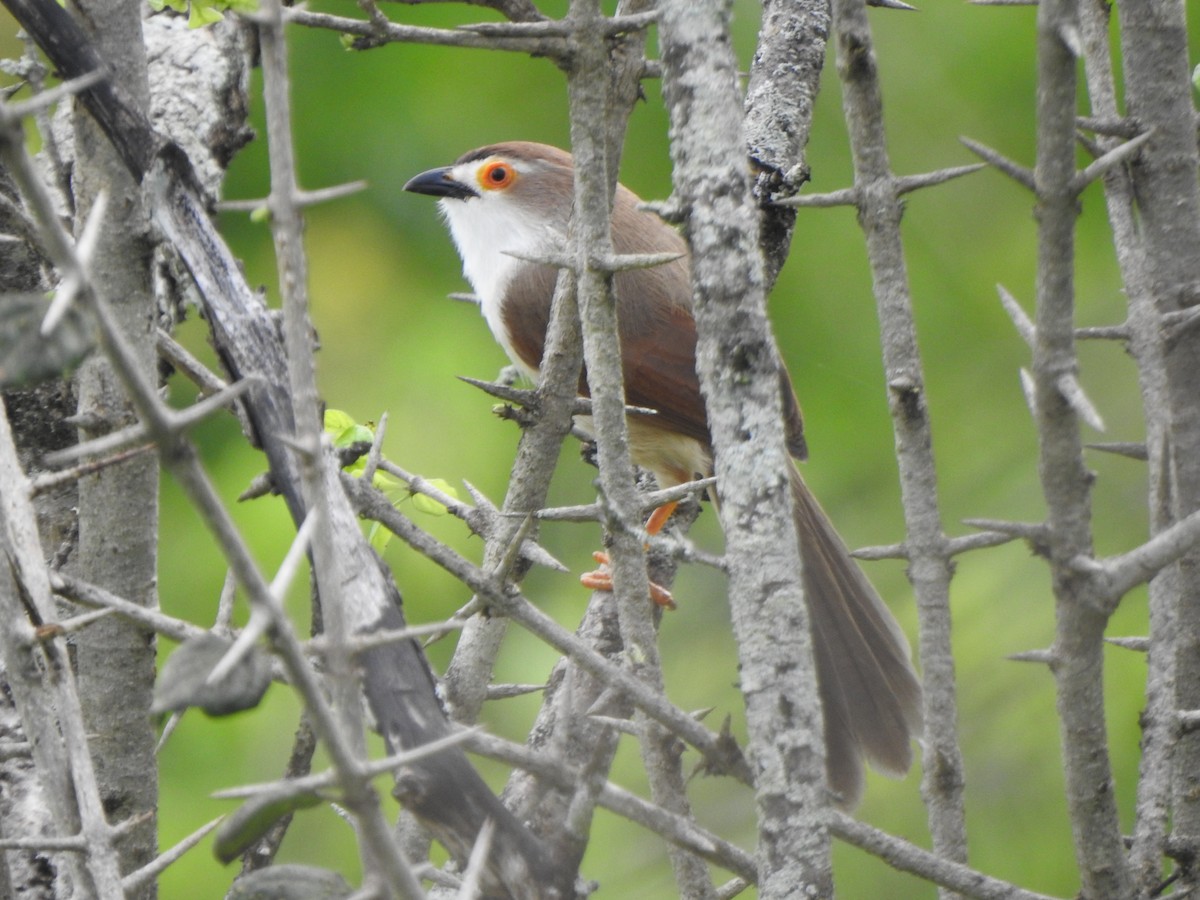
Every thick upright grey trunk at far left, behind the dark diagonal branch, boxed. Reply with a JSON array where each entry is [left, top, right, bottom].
[[71, 0, 158, 883]]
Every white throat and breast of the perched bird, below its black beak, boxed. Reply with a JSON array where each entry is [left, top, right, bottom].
[[438, 193, 562, 380]]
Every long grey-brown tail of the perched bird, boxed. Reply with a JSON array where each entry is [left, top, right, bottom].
[[792, 469, 922, 809]]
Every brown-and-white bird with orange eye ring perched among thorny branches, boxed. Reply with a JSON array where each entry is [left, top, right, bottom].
[[404, 142, 922, 809]]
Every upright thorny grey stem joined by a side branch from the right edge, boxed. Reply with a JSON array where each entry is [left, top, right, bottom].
[[1033, 0, 1130, 896]]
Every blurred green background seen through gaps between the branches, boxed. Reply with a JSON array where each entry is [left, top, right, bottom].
[[6, 0, 1200, 900]]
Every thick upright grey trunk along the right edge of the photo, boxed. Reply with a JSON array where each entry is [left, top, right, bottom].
[[1118, 0, 1200, 884]]
